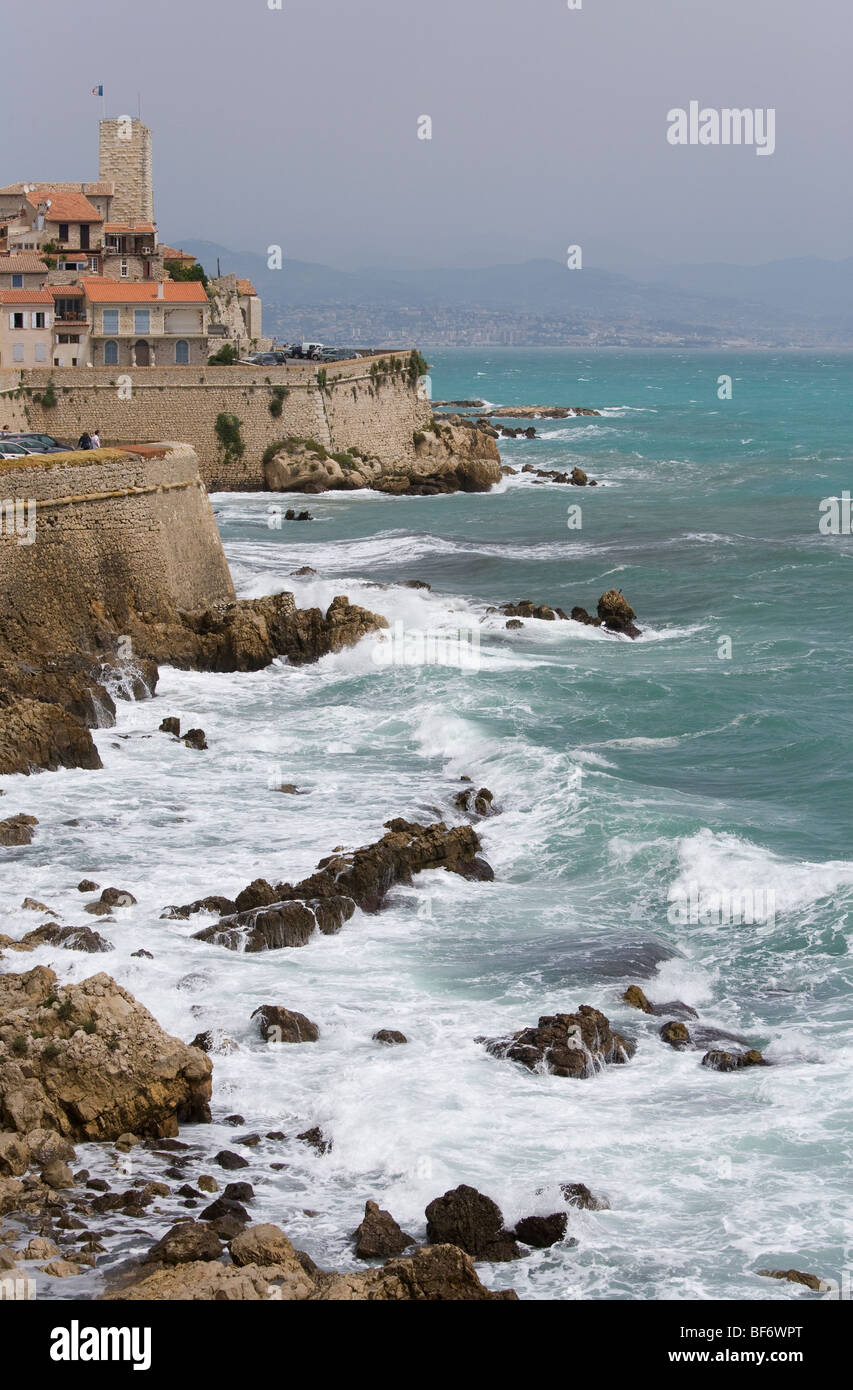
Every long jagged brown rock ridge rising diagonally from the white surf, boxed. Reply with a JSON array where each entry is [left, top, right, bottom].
[[190, 819, 495, 952]]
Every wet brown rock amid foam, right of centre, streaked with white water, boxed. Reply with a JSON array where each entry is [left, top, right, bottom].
[[478, 1004, 636, 1077]]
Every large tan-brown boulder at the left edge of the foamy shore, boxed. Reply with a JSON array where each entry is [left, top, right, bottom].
[[0, 966, 211, 1140]]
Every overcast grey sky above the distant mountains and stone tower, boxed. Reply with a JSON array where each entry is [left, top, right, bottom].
[[0, 0, 853, 274]]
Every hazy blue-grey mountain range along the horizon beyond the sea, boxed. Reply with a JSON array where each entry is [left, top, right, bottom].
[[175, 240, 853, 346]]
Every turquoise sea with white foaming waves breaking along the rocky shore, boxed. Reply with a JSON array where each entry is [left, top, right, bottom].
[[3, 349, 853, 1301]]
